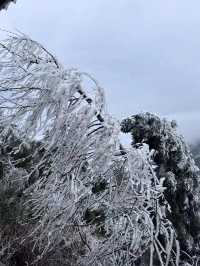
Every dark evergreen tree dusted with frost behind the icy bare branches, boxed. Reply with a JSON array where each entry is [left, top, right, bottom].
[[121, 113, 200, 265]]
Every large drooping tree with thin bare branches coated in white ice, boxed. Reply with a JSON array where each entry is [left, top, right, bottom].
[[0, 35, 179, 266]]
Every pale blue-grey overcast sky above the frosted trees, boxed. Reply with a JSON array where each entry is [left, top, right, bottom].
[[0, 0, 200, 142]]
